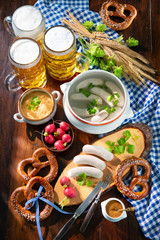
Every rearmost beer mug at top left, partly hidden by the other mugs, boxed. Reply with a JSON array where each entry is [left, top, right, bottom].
[[4, 5, 46, 47]]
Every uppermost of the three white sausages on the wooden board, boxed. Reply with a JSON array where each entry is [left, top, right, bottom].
[[82, 144, 114, 161]]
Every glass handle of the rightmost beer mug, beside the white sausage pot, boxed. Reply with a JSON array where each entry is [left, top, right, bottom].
[[74, 52, 90, 73]]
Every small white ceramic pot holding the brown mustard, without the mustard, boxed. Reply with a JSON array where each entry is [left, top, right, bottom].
[[101, 198, 127, 222]]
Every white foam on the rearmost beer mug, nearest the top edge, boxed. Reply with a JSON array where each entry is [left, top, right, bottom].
[[13, 5, 42, 31]]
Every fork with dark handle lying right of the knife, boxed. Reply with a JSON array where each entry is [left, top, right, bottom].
[[80, 171, 112, 233]]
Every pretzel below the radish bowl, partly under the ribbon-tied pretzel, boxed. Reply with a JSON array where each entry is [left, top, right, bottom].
[[17, 148, 58, 184]]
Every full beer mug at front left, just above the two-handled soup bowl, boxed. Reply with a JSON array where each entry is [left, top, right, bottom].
[[5, 38, 47, 92]]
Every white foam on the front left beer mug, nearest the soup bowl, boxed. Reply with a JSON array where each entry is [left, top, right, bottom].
[[10, 39, 39, 64]]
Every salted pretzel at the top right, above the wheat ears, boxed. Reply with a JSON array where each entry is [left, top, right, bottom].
[[100, 0, 137, 31]]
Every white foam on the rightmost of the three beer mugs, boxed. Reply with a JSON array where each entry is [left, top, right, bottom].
[[45, 26, 74, 52]]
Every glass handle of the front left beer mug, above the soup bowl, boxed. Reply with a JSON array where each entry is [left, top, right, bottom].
[[4, 72, 21, 92]]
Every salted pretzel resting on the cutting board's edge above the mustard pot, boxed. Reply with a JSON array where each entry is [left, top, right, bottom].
[[114, 157, 151, 200]]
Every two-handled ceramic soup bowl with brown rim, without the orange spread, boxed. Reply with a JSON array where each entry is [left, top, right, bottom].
[[13, 88, 61, 125]]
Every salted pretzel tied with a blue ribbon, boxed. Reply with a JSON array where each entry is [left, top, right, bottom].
[[10, 176, 54, 222]]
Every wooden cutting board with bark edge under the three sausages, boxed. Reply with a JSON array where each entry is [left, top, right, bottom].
[[54, 123, 153, 206]]
